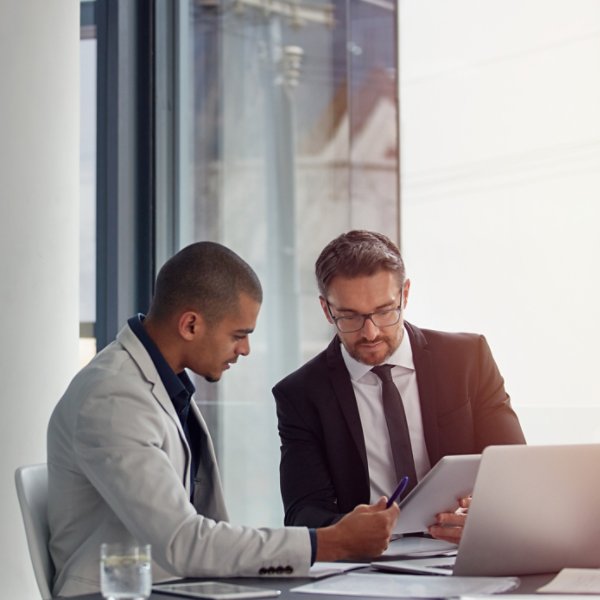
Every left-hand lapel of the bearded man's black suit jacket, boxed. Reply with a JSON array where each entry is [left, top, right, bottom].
[[327, 335, 369, 474]]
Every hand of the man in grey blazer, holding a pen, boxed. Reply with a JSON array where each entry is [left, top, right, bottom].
[[317, 497, 400, 561]]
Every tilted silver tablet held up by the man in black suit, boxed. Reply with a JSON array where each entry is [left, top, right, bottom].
[[393, 454, 481, 535]]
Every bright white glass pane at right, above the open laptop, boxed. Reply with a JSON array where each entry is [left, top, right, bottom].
[[399, 0, 600, 443]]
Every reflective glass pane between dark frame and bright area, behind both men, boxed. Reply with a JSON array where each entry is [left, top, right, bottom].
[[180, 0, 398, 525]]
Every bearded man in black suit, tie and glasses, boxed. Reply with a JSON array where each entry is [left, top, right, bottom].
[[273, 231, 525, 540]]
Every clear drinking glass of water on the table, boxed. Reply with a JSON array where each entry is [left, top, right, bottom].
[[100, 543, 152, 600]]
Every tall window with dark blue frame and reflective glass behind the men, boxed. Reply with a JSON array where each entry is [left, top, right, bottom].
[[89, 0, 399, 526]]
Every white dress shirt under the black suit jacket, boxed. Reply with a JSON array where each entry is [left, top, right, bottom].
[[342, 328, 431, 503]]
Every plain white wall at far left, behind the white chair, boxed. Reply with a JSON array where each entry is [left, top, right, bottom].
[[0, 0, 79, 600]]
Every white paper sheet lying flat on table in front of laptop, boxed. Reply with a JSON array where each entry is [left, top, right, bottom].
[[291, 572, 519, 598]]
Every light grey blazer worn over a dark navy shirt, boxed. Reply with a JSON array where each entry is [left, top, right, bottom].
[[48, 326, 311, 596]]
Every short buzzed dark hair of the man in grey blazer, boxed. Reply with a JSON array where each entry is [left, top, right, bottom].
[[149, 242, 262, 324]]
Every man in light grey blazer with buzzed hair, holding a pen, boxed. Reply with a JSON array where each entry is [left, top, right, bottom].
[[48, 242, 399, 596]]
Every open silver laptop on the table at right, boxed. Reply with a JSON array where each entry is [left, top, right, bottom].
[[371, 444, 600, 576]]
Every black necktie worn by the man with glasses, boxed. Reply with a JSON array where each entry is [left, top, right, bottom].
[[371, 365, 417, 494]]
